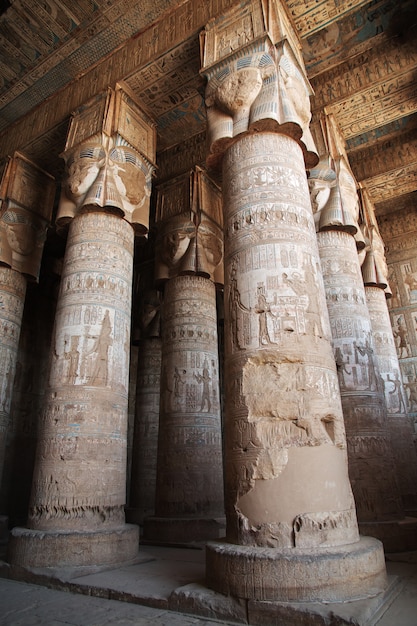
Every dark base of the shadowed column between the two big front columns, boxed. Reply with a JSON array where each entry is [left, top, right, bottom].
[[143, 517, 226, 544]]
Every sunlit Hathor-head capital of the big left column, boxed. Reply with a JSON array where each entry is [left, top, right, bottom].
[[57, 89, 155, 234]]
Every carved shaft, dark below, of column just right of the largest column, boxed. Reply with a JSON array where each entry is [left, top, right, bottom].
[[317, 230, 403, 522]]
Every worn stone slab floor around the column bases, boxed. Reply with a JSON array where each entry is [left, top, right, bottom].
[[0, 545, 417, 626]]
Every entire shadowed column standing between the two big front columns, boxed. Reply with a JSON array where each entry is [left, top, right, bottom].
[[144, 168, 228, 543]]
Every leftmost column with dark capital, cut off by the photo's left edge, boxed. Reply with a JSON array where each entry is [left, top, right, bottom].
[[0, 153, 55, 532]]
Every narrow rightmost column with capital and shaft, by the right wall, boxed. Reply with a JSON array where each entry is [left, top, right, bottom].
[[361, 189, 417, 516]]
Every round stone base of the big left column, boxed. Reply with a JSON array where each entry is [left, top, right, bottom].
[[7, 524, 139, 568]]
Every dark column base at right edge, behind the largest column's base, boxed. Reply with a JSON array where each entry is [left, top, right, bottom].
[[358, 517, 417, 552]]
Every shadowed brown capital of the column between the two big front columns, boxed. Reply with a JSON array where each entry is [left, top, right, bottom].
[[156, 168, 223, 284]]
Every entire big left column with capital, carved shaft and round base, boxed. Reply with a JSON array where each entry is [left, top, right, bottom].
[[8, 87, 155, 567]]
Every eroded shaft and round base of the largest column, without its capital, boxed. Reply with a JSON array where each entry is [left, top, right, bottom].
[[203, 133, 384, 600]]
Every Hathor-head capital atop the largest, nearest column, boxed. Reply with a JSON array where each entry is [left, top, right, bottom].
[[201, 0, 318, 167]]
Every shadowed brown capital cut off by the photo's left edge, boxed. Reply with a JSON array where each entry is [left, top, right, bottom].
[[0, 153, 55, 281]]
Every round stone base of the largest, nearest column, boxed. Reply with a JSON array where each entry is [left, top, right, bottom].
[[206, 537, 388, 602]]
